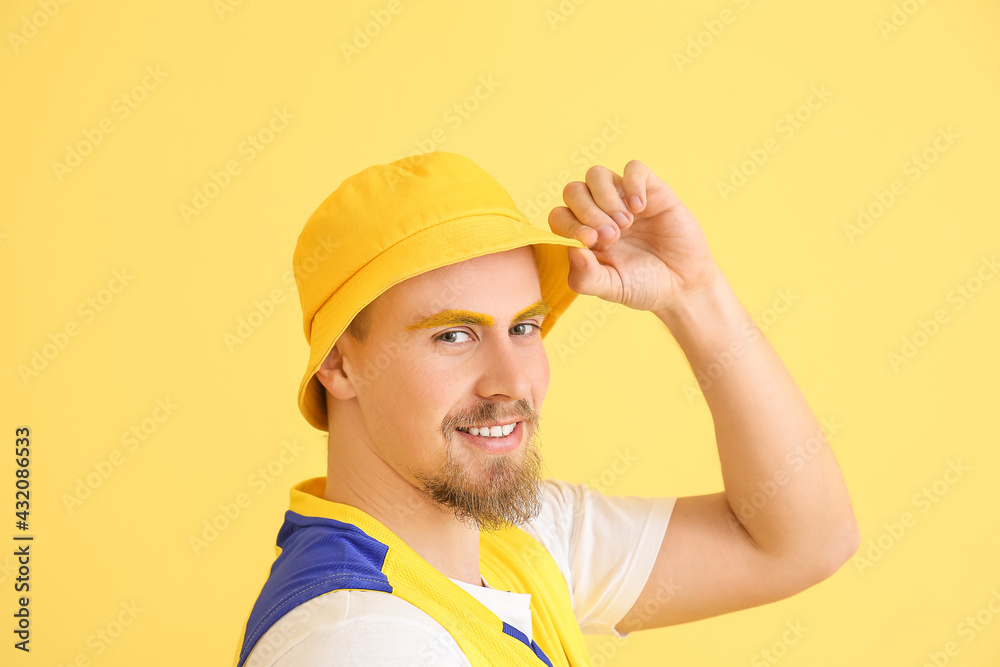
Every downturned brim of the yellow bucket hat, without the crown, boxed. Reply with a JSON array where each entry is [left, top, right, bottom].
[[298, 215, 587, 431]]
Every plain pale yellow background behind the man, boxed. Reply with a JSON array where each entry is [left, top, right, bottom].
[[0, 0, 1000, 667]]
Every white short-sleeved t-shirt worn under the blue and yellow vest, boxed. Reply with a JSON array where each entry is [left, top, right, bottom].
[[246, 479, 676, 667]]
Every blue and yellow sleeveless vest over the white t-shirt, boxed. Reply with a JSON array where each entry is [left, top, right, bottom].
[[233, 477, 590, 667]]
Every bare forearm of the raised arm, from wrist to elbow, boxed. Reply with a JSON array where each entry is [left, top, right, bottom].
[[656, 271, 857, 567]]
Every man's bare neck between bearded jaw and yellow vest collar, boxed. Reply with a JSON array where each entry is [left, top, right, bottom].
[[323, 422, 483, 586]]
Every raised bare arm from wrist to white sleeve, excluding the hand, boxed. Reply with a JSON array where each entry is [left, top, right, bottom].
[[617, 271, 859, 632]]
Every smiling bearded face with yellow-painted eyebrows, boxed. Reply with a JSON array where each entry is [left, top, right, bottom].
[[330, 247, 549, 530]]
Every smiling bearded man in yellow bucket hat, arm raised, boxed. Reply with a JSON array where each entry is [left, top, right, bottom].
[[234, 152, 859, 667]]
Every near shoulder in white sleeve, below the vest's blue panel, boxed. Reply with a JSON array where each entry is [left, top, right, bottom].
[[246, 590, 469, 667]]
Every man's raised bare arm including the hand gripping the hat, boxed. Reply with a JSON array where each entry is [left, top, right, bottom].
[[549, 160, 860, 632]]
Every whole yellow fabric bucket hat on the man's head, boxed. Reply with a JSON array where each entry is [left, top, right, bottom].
[[292, 151, 587, 431]]
